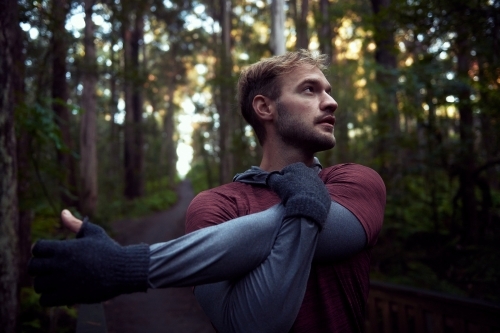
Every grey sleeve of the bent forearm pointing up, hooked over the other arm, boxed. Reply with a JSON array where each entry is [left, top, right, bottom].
[[195, 218, 319, 333]]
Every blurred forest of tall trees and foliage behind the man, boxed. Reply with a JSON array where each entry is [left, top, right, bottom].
[[0, 0, 500, 332]]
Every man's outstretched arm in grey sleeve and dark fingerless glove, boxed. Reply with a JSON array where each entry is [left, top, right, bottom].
[[30, 192, 365, 306]]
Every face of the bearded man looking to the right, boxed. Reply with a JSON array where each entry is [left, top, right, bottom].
[[276, 66, 338, 153]]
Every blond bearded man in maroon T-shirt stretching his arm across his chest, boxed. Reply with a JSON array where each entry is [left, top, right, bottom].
[[30, 51, 385, 332]]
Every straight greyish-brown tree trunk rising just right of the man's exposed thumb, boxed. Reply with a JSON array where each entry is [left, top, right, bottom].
[[80, 0, 97, 216]]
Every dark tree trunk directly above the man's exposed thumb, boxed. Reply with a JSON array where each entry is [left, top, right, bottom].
[[52, 0, 78, 207]]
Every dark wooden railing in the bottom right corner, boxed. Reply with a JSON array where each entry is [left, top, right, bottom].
[[366, 281, 500, 333]]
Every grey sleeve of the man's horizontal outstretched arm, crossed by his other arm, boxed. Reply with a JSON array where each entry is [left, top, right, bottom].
[[148, 202, 366, 288]]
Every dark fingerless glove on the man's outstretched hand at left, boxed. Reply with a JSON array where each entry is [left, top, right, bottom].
[[28, 219, 149, 306]]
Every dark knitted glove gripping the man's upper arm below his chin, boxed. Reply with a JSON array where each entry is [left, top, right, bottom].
[[267, 162, 332, 229]]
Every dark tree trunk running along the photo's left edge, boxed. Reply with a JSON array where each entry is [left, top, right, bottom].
[[0, 0, 19, 333]]
